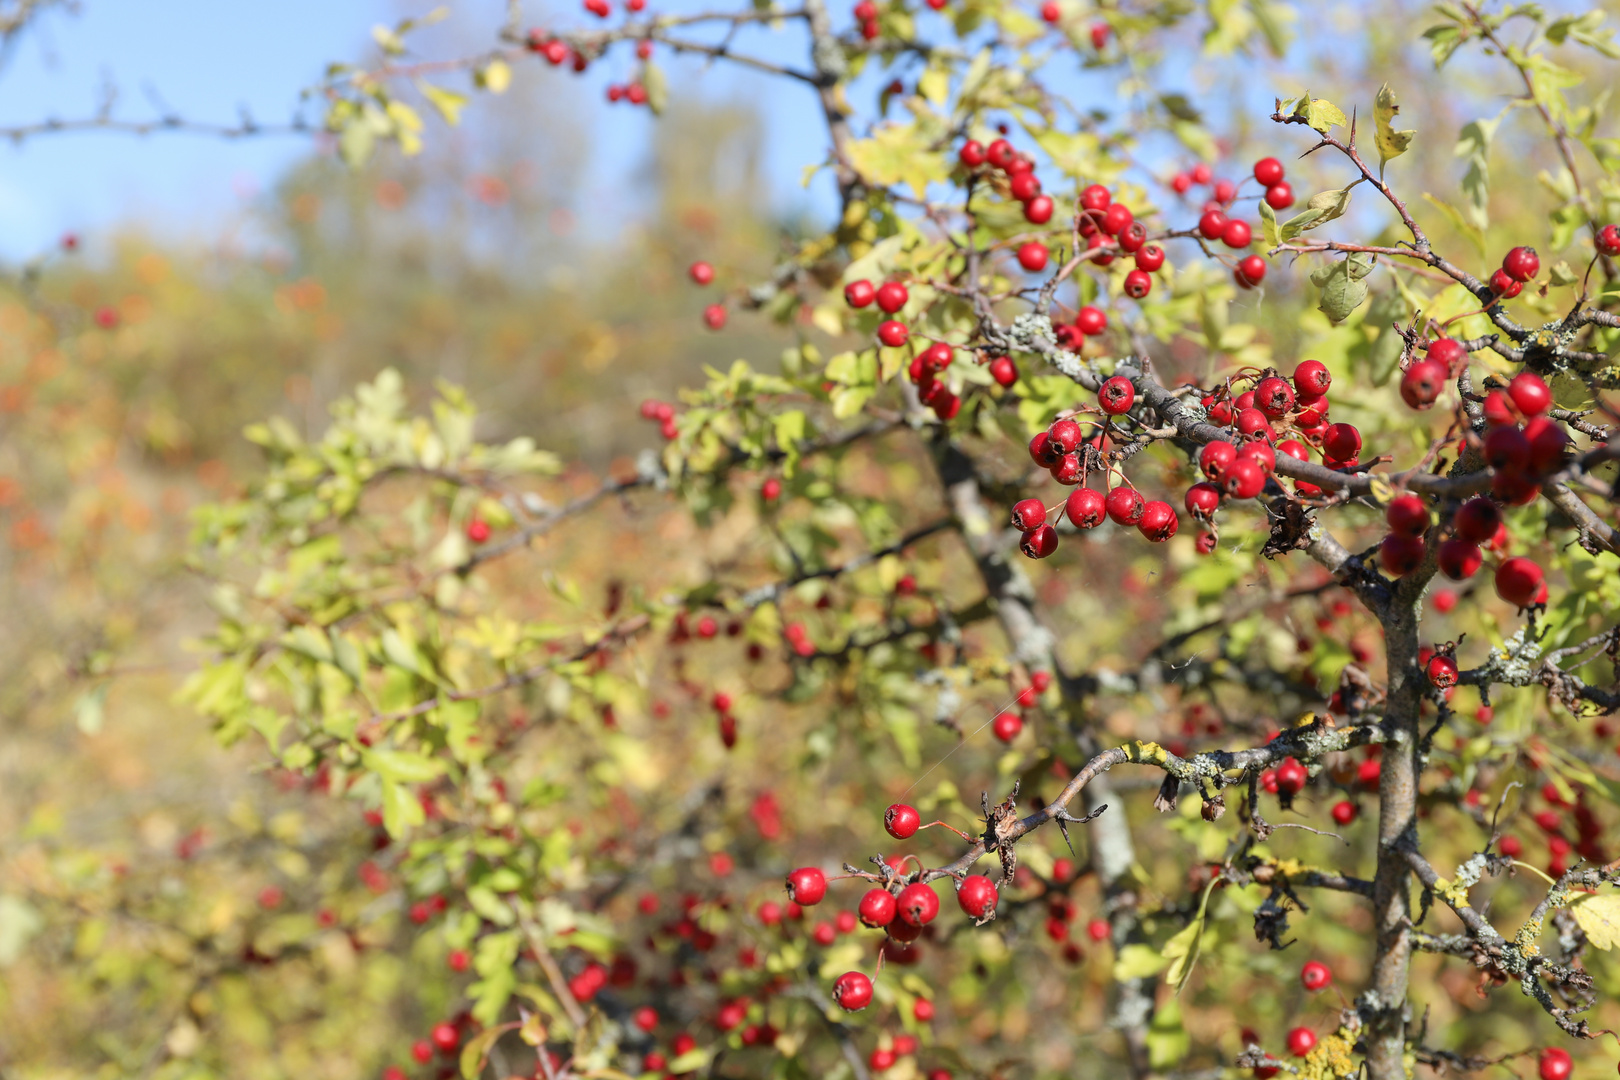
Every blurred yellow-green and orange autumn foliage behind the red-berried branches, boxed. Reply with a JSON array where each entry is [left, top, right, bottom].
[[0, 3, 1620, 1080]]
